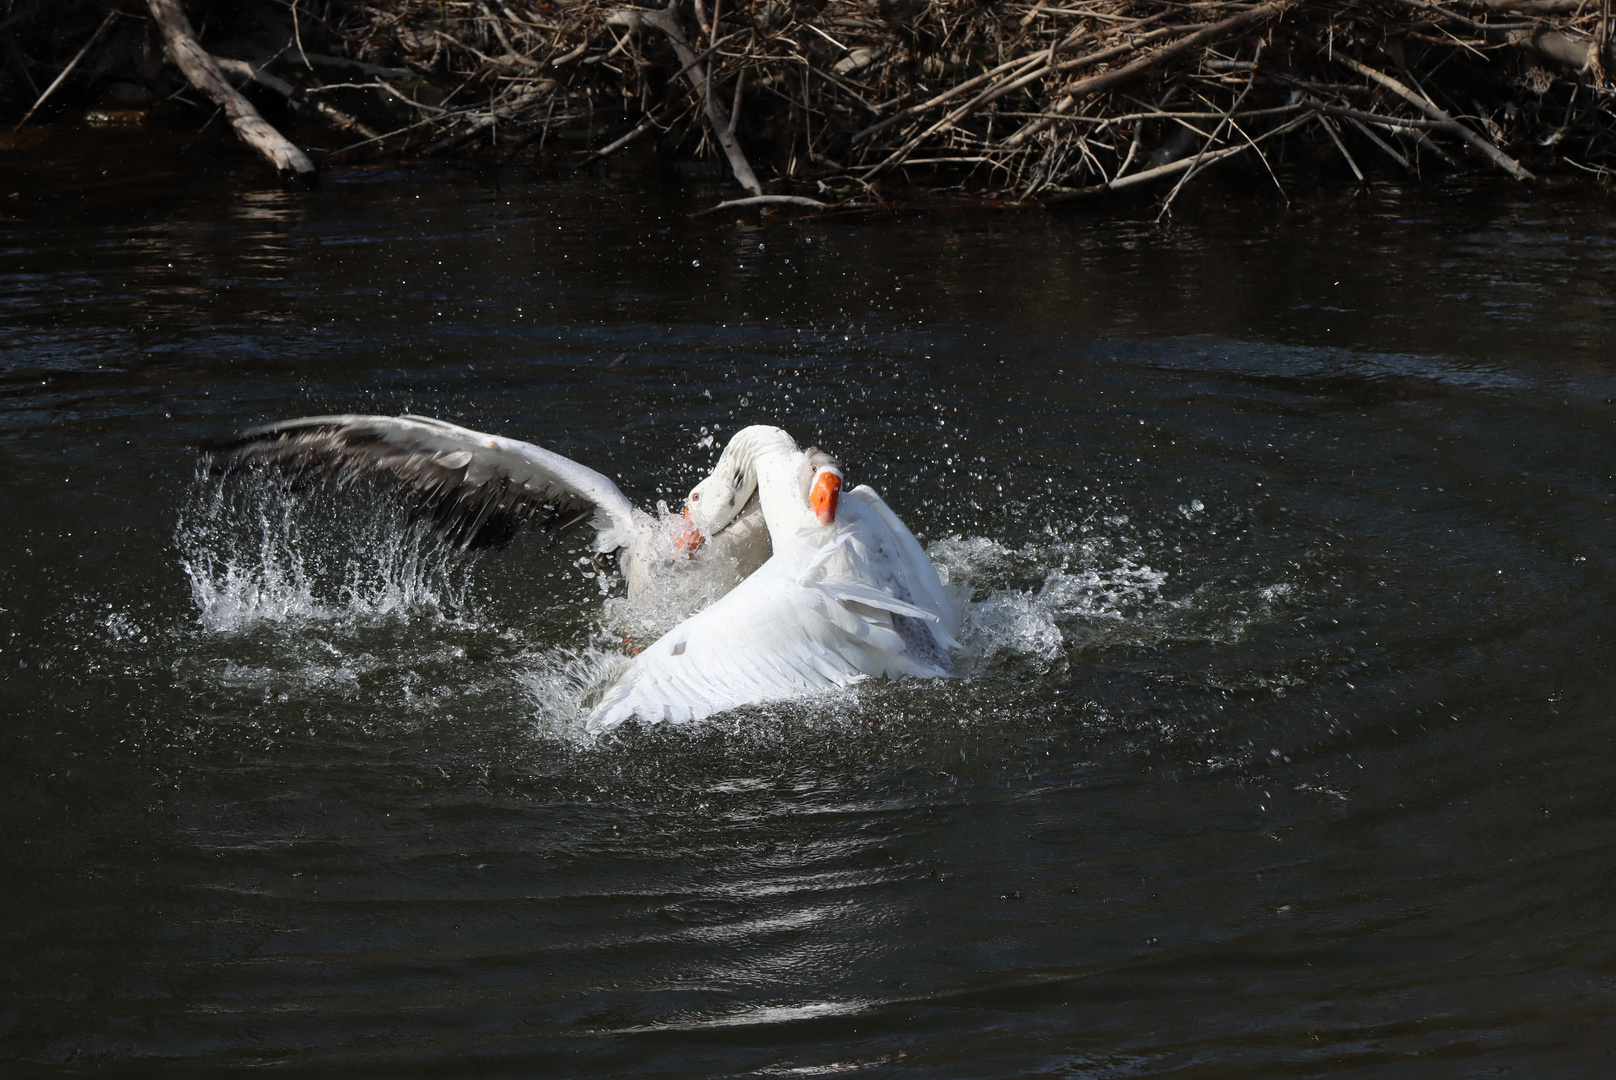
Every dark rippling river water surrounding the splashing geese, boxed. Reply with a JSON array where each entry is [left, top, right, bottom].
[[0, 133, 1616, 1078]]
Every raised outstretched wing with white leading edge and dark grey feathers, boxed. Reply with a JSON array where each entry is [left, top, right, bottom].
[[202, 416, 637, 553]]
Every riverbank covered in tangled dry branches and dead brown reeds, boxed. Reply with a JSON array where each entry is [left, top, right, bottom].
[[0, 0, 1613, 213]]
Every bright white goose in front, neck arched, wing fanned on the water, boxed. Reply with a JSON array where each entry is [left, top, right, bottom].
[[588, 427, 960, 731]]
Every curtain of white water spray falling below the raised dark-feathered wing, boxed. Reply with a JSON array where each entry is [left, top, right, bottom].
[[175, 470, 472, 632]]
